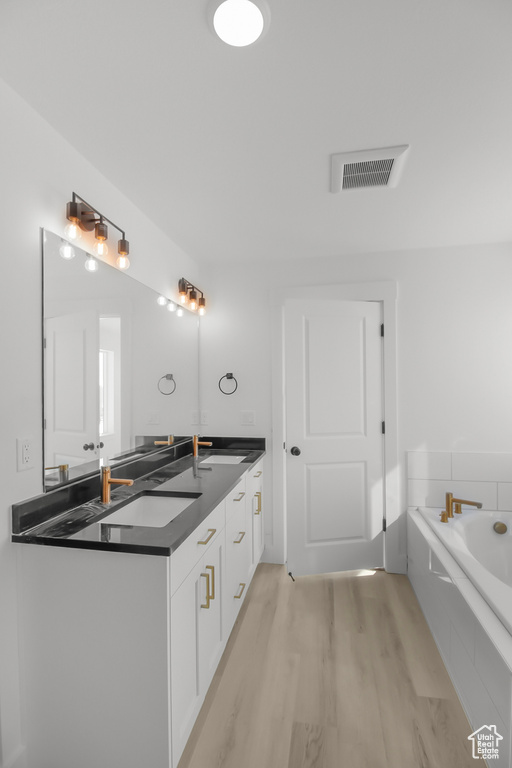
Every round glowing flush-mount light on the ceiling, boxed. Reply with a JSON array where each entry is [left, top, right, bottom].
[[210, 0, 270, 48]]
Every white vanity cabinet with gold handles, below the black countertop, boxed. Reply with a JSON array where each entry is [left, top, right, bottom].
[[19, 463, 262, 768]]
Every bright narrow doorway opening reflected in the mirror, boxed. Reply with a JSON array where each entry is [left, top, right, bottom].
[[98, 317, 122, 460]]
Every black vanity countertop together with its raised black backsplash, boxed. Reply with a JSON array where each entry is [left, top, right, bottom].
[[12, 438, 265, 556]]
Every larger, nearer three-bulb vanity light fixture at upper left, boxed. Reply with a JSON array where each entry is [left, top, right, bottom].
[[64, 192, 130, 271]]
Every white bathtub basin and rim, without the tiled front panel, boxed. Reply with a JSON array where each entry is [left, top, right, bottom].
[[418, 507, 512, 634]]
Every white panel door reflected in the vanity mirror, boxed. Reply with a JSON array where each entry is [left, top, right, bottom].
[[44, 311, 99, 480]]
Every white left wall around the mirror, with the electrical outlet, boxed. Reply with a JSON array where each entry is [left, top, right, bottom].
[[0, 76, 197, 768]]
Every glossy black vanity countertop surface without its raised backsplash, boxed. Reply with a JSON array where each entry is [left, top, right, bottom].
[[12, 449, 265, 557]]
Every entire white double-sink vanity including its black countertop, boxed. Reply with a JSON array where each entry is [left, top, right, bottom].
[[13, 450, 264, 768]]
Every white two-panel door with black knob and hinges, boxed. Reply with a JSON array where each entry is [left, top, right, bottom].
[[285, 300, 384, 575]]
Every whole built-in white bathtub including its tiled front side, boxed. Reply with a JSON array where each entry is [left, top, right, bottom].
[[407, 507, 512, 768]]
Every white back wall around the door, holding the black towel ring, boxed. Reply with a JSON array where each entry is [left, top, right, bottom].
[[202, 244, 512, 570]]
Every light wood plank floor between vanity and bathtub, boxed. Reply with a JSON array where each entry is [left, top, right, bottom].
[[179, 564, 476, 768]]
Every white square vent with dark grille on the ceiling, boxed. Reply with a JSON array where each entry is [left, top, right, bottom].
[[331, 144, 409, 192]]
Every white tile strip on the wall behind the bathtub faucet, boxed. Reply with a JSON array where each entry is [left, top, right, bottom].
[[407, 451, 512, 512]]
